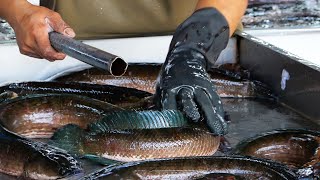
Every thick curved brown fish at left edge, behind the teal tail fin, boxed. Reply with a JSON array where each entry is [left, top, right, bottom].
[[0, 94, 121, 138]]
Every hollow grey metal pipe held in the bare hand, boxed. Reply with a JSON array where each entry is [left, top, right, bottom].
[[49, 32, 128, 76]]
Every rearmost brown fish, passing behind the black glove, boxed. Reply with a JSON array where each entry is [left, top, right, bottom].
[[56, 64, 270, 98]]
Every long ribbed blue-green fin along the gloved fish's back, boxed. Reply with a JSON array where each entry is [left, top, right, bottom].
[[88, 110, 188, 133]]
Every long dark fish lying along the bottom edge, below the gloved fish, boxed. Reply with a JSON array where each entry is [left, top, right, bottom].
[[84, 156, 296, 180]]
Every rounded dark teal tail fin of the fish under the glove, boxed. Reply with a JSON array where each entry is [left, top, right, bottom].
[[48, 124, 85, 156]]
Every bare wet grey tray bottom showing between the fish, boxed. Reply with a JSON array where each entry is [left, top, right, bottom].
[[0, 95, 320, 179]]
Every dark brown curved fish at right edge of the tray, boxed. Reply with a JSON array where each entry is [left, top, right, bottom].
[[234, 130, 320, 178]]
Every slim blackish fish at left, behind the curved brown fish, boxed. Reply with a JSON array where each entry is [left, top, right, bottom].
[[0, 82, 151, 105]]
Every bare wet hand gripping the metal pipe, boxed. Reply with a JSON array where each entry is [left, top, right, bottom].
[[0, 0, 75, 61]]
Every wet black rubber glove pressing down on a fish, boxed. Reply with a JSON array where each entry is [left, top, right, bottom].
[[155, 8, 229, 135]]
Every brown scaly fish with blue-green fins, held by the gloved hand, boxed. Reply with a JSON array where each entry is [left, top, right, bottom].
[[50, 111, 220, 161]]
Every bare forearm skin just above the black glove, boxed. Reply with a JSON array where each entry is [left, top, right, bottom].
[[196, 0, 248, 36]]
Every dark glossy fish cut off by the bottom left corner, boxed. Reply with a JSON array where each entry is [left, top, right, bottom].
[[0, 125, 83, 179]]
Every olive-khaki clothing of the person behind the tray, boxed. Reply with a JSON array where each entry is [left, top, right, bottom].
[[42, 0, 197, 39]]
